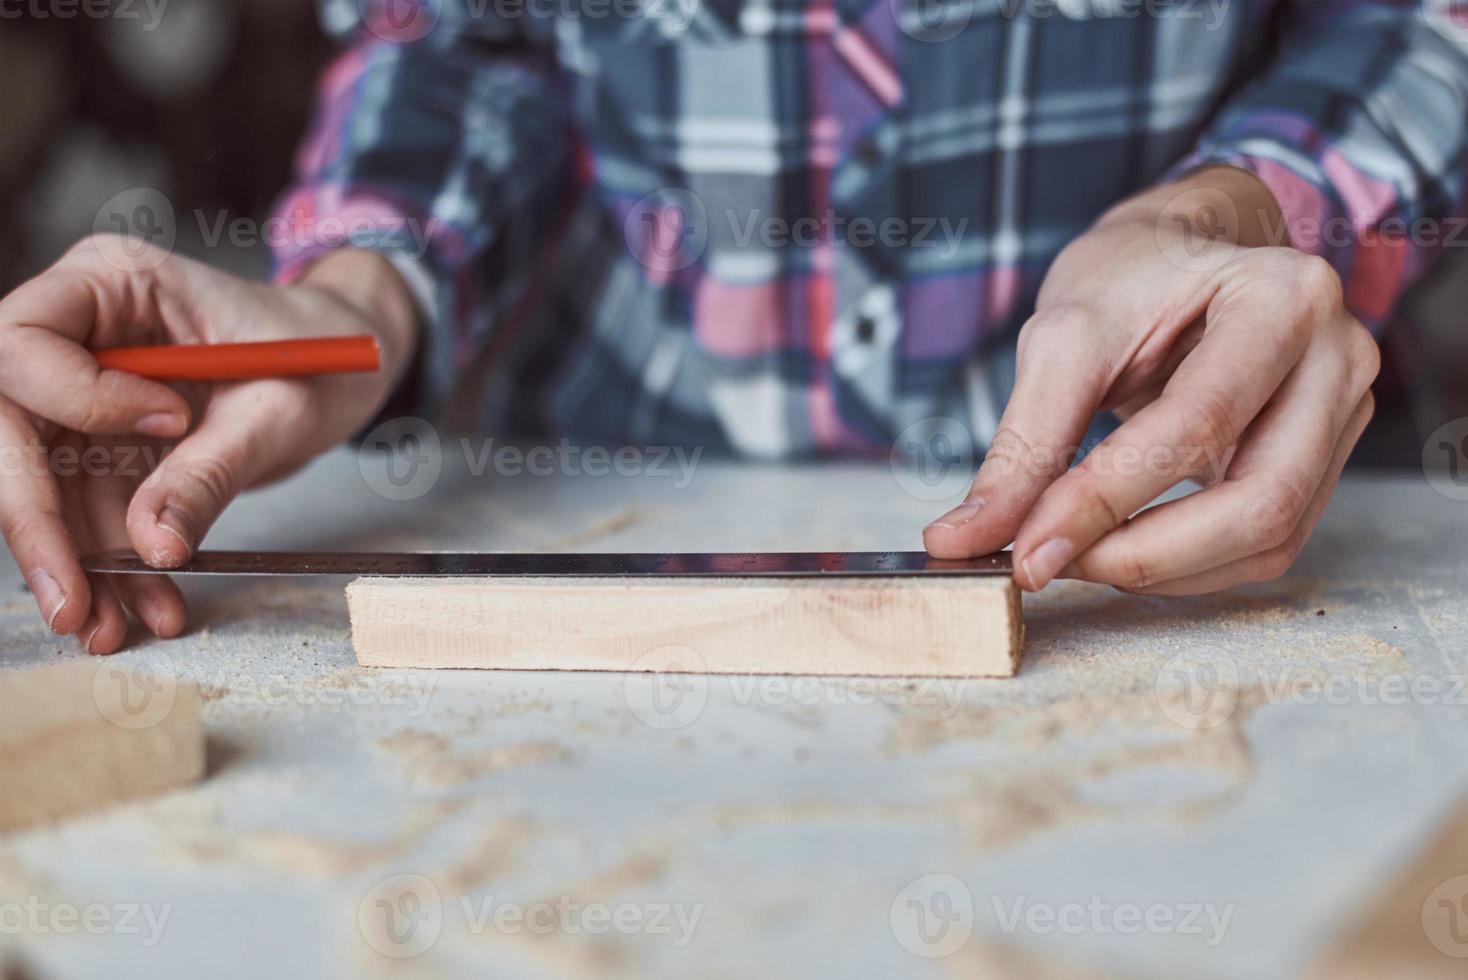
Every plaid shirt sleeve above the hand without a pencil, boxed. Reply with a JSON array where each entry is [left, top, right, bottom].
[[1173, 0, 1468, 329]]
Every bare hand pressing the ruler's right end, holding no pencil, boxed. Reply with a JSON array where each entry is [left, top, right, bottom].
[[923, 167, 1380, 594]]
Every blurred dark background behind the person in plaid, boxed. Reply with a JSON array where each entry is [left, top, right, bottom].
[[0, 0, 1468, 468]]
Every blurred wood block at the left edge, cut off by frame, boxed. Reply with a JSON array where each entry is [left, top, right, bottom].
[[0, 657, 204, 830]]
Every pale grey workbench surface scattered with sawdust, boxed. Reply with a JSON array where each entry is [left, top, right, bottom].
[[0, 450, 1468, 979]]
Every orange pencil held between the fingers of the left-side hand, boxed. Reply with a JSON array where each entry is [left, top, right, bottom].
[[94, 336, 382, 381]]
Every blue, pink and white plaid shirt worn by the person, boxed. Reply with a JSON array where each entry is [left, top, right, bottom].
[[276, 0, 1468, 456]]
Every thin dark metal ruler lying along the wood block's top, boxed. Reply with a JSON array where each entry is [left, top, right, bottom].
[[82, 552, 1010, 578]]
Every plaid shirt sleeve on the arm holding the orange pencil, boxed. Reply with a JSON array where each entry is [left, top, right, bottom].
[[270, 0, 573, 418]]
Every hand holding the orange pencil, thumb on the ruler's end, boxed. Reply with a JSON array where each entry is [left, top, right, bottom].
[[0, 236, 417, 653]]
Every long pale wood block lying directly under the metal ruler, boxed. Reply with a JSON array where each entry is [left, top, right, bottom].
[[346, 575, 1023, 676]]
